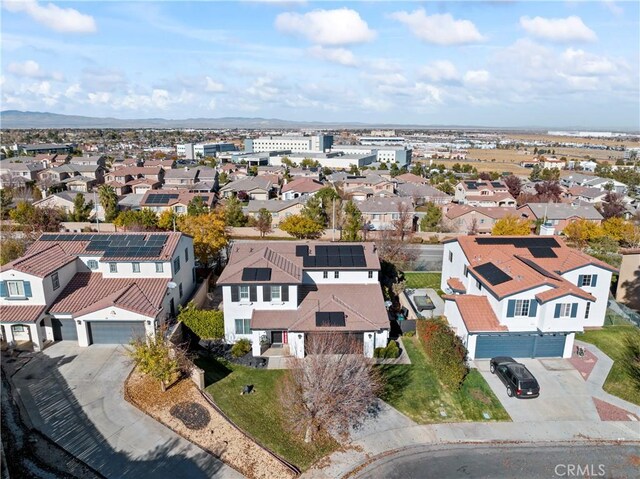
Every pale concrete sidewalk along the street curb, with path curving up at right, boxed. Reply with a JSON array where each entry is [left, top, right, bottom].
[[302, 342, 640, 479]]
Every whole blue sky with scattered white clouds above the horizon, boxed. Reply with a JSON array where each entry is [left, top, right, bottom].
[[0, 0, 640, 131]]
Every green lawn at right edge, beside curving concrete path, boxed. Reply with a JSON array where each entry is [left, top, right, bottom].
[[576, 325, 640, 405]]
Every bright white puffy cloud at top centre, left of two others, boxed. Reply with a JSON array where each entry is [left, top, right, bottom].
[[275, 8, 376, 45]]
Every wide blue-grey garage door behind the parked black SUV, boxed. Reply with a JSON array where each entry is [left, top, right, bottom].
[[475, 333, 566, 359]]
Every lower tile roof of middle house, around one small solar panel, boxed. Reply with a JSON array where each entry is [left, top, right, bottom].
[[251, 284, 389, 332]]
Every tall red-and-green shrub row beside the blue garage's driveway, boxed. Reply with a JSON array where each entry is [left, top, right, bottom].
[[417, 318, 469, 390]]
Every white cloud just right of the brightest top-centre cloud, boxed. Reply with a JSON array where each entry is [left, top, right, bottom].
[[391, 8, 485, 45]]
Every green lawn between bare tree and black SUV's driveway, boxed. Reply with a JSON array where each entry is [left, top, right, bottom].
[[381, 337, 511, 424]]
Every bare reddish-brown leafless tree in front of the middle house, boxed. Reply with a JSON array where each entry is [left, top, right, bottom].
[[280, 333, 382, 442]]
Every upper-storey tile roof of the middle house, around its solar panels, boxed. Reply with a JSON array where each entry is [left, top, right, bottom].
[[218, 241, 380, 284]]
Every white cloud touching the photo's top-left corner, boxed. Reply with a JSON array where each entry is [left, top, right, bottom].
[[2, 0, 98, 33]]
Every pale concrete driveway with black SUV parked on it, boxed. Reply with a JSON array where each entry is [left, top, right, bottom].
[[475, 359, 600, 422]]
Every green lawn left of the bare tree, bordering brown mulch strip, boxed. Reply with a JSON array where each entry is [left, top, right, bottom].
[[196, 358, 338, 470]]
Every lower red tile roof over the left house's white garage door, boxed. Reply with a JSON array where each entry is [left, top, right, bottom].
[[49, 273, 168, 318]]
